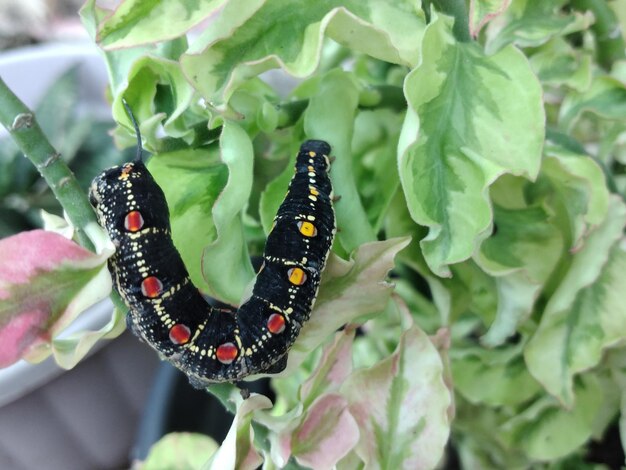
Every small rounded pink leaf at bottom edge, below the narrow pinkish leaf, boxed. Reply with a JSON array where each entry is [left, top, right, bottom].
[[291, 394, 359, 470]]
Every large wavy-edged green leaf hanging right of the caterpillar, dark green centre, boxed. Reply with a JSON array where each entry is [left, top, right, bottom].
[[398, 16, 544, 276]]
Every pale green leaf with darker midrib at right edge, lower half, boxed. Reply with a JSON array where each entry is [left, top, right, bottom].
[[524, 198, 626, 407]]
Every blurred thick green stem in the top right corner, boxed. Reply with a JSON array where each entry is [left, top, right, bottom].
[[571, 0, 626, 70]]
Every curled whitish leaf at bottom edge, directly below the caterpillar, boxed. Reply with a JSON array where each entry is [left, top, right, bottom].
[[204, 393, 272, 470]]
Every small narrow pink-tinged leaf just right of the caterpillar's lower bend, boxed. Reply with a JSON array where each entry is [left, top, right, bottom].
[[300, 328, 355, 407]]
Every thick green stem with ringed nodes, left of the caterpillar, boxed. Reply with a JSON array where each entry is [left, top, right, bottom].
[[0, 79, 97, 251]]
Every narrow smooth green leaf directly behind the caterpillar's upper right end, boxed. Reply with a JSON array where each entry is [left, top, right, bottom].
[[304, 70, 376, 253]]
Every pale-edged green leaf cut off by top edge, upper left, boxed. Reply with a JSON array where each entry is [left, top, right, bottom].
[[96, 0, 226, 50]]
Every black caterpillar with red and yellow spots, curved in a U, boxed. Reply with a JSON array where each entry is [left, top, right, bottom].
[[89, 114, 335, 387]]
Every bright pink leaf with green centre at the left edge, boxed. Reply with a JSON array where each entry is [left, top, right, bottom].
[[0, 230, 111, 367]]
